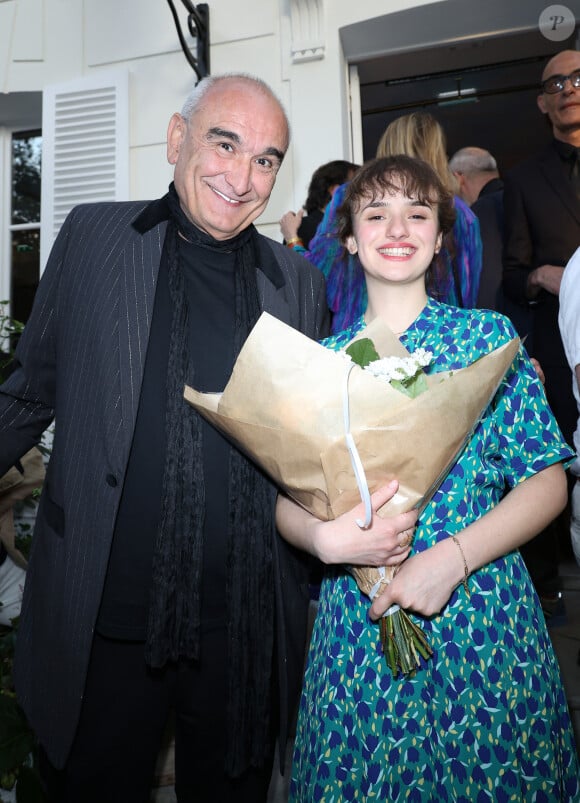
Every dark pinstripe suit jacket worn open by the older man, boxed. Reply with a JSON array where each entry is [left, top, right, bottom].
[[0, 201, 327, 766]]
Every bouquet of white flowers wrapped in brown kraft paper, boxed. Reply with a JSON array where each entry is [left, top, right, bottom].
[[184, 313, 519, 674]]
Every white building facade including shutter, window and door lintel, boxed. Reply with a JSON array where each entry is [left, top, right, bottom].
[[0, 0, 578, 320]]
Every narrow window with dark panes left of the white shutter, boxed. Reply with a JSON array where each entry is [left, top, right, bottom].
[[9, 130, 42, 323]]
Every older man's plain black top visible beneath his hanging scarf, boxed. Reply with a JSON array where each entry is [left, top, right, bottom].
[[97, 232, 235, 641]]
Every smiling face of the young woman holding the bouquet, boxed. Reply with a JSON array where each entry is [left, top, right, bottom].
[[346, 184, 441, 285]]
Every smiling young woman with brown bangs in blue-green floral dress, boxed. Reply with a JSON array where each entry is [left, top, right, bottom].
[[277, 156, 580, 803]]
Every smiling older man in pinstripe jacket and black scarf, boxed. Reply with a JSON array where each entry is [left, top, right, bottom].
[[0, 75, 416, 803]]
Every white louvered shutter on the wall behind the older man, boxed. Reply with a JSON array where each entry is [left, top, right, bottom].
[[40, 71, 129, 270]]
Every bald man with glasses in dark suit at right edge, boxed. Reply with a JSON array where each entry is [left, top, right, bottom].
[[503, 50, 580, 613]]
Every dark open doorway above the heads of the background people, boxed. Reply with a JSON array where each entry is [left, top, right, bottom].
[[341, 0, 580, 170]]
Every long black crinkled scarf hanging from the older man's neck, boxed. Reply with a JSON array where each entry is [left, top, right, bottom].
[[146, 184, 274, 776]]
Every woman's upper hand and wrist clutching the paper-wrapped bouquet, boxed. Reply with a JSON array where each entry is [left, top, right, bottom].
[[276, 480, 417, 566]]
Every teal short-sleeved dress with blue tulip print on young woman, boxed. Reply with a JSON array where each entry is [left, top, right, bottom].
[[290, 300, 580, 803]]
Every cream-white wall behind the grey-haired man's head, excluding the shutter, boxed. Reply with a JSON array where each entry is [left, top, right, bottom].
[[0, 0, 440, 243]]
